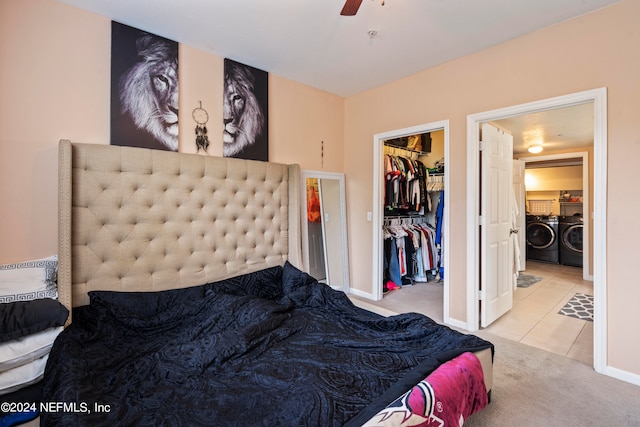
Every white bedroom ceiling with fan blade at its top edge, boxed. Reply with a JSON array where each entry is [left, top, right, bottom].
[[60, 0, 619, 97]]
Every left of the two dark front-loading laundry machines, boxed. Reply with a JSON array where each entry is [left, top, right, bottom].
[[527, 215, 560, 264]]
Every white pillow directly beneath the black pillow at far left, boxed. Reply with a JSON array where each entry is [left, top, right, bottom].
[[0, 326, 64, 372]]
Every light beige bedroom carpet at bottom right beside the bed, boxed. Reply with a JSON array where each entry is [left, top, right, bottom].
[[464, 331, 640, 427]]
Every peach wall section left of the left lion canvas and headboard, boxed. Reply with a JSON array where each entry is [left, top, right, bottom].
[[0, 0, 110, 263]]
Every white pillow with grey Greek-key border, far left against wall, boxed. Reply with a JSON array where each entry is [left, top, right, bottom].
[[0, 255, 58, 303]]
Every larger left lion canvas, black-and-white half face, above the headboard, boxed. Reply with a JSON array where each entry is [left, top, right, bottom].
[[111, 22, 178, 151]]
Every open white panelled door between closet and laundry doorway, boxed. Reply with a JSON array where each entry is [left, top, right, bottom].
[[480, 123, 513, 328]]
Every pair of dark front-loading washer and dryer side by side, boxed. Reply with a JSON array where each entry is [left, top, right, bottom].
[[527, 215, 584, 267]]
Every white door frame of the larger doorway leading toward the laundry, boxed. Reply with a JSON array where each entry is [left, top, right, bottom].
[[466, 87, 607, 374]]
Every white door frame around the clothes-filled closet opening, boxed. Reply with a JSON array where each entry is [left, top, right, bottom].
[[372, 120, 451, 323]]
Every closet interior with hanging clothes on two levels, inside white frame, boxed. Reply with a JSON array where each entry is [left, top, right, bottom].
[[382, 131, 445, 293]]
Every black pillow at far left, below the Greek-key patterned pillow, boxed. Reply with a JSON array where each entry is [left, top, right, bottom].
[[0, 298, 69, 343]]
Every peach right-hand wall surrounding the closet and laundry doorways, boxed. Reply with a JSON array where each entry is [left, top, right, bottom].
[[345, 0, 640, 374]]
